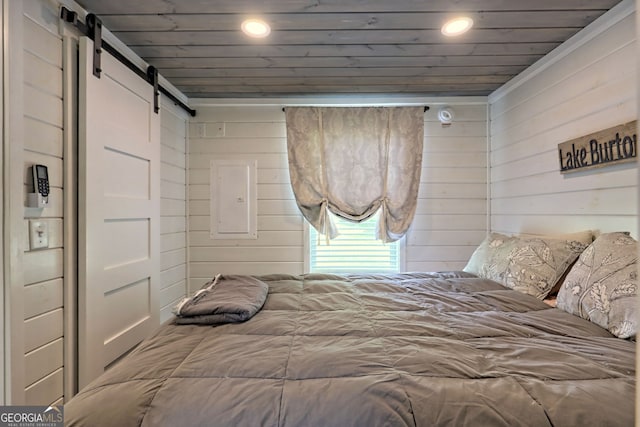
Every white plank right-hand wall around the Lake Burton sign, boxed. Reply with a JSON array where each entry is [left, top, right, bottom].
[[489, 7, 638, 237]]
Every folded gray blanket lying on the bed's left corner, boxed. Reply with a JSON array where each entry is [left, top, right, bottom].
[[174, 274, 269, 325]]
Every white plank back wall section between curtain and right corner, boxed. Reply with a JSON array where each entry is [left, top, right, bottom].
[[406, 105, 488, 271]]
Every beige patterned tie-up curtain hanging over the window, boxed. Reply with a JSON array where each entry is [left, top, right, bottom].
[[286, 107, 424, 242]]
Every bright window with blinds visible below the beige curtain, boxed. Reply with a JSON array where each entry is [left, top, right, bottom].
[[309, 211, 400, 273]]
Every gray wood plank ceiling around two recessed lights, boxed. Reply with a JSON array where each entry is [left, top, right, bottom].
[[77, 0, 620, 98]]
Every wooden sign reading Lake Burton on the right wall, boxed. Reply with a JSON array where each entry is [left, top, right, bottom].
[[558, 120, 638, 173]]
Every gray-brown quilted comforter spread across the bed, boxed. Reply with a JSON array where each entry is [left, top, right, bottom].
[[65, 273, 635, 427]]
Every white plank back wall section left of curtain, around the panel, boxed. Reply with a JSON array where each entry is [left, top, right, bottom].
[[189, 107, 304, 291]]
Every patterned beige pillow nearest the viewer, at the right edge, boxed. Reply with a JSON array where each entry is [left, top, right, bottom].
[[558, 233, 638, 338]]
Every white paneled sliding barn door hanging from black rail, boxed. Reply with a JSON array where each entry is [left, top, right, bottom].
[[78, 37, 160, 388]]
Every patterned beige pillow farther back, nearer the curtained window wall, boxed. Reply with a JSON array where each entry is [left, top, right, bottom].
[[463, 233, 587, 300]]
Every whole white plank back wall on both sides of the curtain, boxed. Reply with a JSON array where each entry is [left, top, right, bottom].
[[189, 105, 487, 291]]
